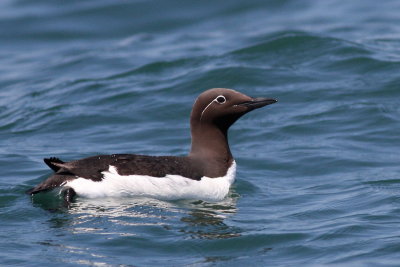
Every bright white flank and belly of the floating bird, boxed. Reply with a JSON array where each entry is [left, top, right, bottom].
[[64, 162, 236, 201]]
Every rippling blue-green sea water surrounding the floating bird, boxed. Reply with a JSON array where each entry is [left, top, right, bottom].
[[0, 0, 400, 266]]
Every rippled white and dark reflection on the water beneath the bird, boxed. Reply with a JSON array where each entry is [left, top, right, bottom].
[[29, 190, 240, 239]]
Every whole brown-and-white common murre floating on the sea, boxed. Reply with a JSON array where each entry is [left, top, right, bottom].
[[26, 88, 276, 203]]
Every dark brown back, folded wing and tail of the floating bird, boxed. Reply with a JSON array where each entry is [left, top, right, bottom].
[[26, 154, 204, 194]]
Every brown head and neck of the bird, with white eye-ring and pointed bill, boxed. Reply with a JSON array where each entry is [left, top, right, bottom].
[[190, 88, 276, 161]]
